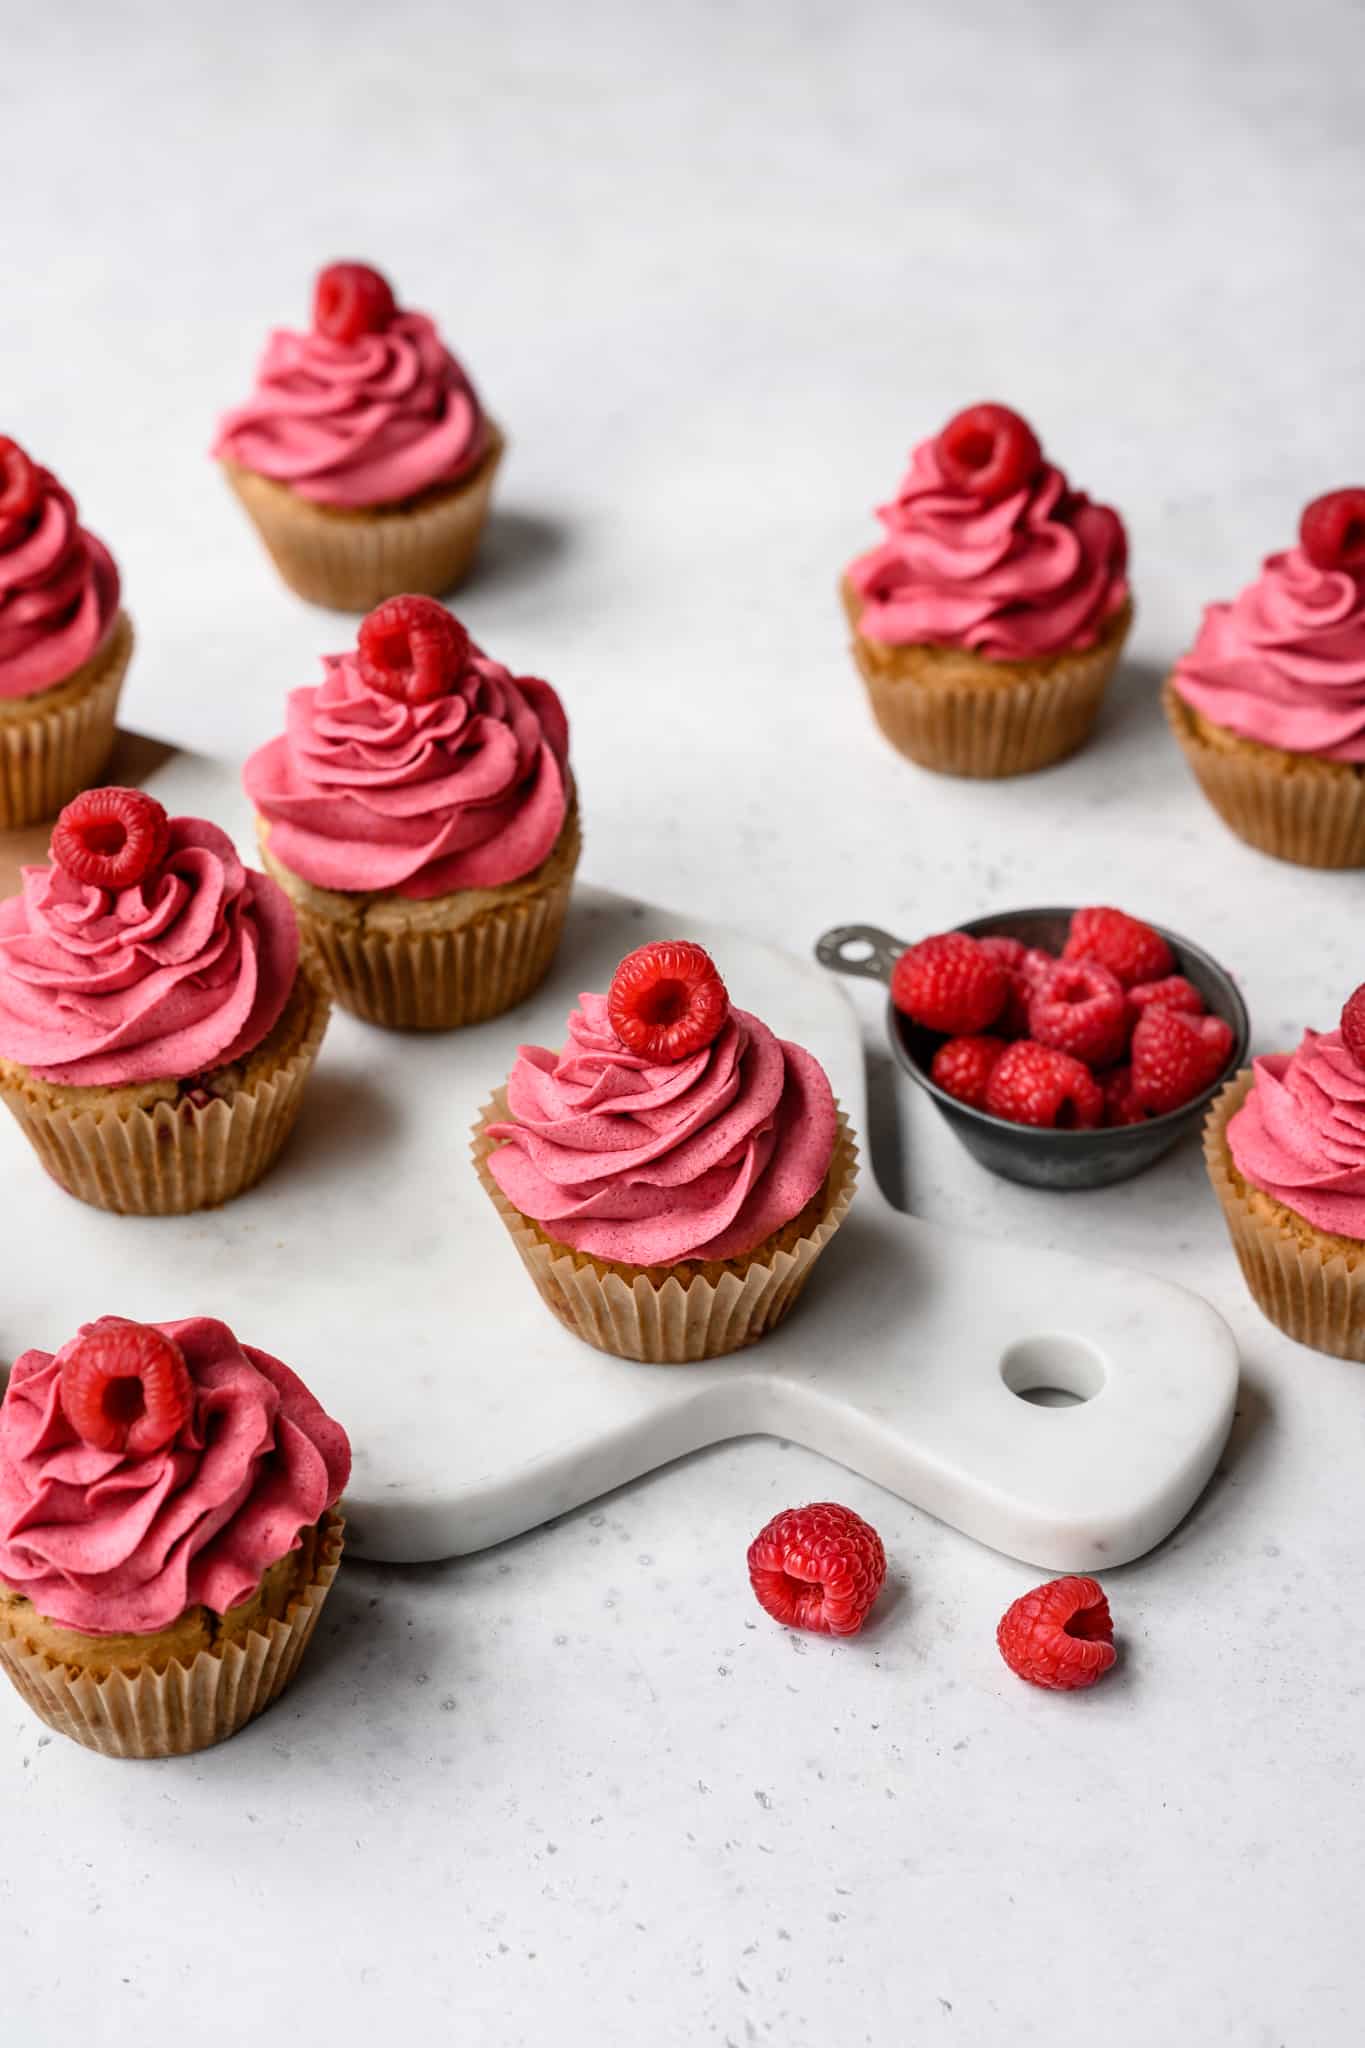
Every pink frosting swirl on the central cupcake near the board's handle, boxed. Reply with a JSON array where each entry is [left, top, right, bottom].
[[489, 995, 837, 1266]]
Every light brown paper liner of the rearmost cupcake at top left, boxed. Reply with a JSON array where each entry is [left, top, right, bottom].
[[223, 428, 503, 612]]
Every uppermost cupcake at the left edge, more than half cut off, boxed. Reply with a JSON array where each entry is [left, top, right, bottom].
[[0, 436, 133, 831]]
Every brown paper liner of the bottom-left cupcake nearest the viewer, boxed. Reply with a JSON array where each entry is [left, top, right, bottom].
[[0, 1509, 346, 1757]]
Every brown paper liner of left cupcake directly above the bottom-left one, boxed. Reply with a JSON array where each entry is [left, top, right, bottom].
[[0, 973, 329, 1217]]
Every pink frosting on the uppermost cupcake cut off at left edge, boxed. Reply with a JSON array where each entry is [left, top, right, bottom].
[[0, 469, 119, 698]]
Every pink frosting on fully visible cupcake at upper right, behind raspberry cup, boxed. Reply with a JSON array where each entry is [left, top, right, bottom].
[[849, 440, 1128, 662]]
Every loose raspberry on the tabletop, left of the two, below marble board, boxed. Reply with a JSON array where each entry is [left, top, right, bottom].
[[749, 1501, 886, 1636]]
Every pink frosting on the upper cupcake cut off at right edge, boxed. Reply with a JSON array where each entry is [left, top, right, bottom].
[[1171, 547, 1365, 762]]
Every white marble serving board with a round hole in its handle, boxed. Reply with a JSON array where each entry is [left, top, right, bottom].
[[0, 748, 1238, 1571]]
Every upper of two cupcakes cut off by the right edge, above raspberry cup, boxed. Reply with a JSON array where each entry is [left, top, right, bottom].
[[1164, 487, 1365, 868]]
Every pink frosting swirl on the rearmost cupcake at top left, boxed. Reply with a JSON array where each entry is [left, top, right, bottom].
[[213, 313, 489, 506]]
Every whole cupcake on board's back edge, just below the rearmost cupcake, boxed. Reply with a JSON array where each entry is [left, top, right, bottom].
[[244, 596, 579, 1030]]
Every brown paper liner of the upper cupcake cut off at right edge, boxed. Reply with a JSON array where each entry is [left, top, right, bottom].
[[1162, 678, 1365, 868]]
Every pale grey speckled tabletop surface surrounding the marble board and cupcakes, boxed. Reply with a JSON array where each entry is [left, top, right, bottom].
[[0, 0, 1365, 2048]]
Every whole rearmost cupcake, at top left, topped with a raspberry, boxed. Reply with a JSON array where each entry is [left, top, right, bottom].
[[213, 262, 503, 612]]
